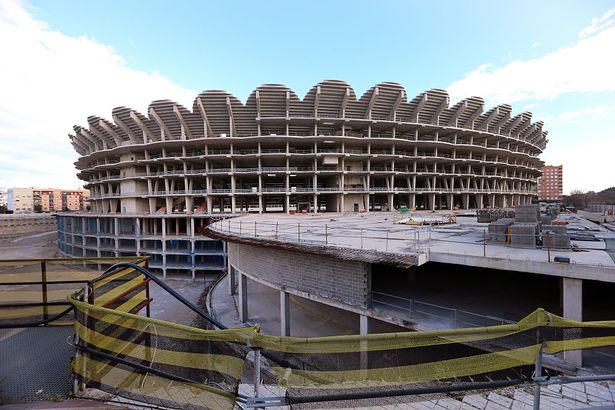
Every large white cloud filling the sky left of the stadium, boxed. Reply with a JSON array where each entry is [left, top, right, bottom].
[[0, 0, 196, 187]]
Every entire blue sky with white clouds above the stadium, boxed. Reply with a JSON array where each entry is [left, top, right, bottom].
[[0, 0, 615, 191]]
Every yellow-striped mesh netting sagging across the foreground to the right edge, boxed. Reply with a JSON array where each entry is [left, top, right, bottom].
[[70, 262, 615, 409]]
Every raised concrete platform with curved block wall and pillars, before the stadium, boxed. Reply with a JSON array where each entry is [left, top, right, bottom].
[[208, 213, 615, 370]]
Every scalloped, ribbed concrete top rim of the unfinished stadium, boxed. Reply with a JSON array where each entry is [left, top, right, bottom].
[[70, 80, 546, 155]]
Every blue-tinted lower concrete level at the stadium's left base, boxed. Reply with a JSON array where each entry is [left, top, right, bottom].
[[57, 213, 226, 280]]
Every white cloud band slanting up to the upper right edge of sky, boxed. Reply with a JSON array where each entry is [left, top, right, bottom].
[[448, 9, 615, 104]]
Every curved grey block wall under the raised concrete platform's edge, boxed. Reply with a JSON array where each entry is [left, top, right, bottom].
[[228, 243, 370, 308]]
